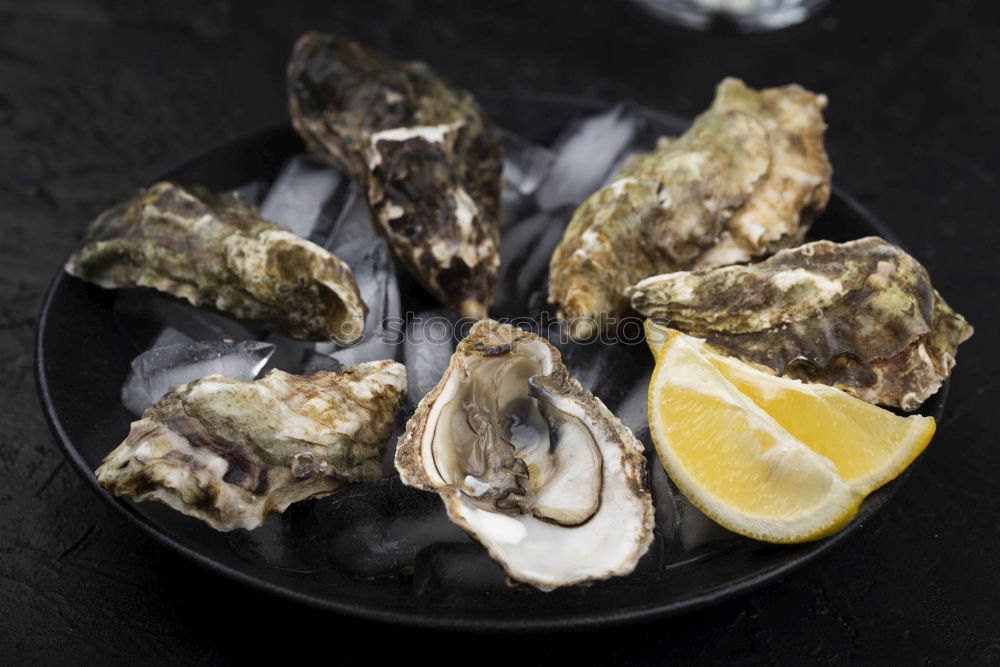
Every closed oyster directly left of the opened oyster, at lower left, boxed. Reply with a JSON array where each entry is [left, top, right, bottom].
[[97, 361, 406, 530]]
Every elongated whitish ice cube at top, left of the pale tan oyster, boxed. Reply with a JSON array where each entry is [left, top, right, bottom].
[[537, 102, 645, 210]]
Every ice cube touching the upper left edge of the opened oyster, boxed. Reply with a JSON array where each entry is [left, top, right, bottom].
[[403, 308, 456, 403]]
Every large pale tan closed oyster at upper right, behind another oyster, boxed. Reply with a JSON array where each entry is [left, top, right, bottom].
[[549, 78, 831, 339]]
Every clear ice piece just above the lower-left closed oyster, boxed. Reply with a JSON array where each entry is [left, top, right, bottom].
[[123, 341, 274, 414]]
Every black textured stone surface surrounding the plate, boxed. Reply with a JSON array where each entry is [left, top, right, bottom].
[[0, 0, 1000, 665]]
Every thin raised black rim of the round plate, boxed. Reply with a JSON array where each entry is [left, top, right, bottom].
[[34, 93, 936, 632]]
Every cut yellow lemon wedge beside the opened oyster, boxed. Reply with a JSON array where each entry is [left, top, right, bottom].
[[647, 325, 934, 542]]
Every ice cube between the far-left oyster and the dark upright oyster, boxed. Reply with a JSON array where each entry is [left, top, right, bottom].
[[260, 153, 346, 243]]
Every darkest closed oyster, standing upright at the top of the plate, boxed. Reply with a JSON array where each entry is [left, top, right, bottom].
[[288, 32, 502, 319]]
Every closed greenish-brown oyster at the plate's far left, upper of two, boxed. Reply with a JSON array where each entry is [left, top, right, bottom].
[[65, 181, 367, 343]]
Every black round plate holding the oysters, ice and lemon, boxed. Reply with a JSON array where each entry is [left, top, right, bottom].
[[36, 95, 947, 630]]
